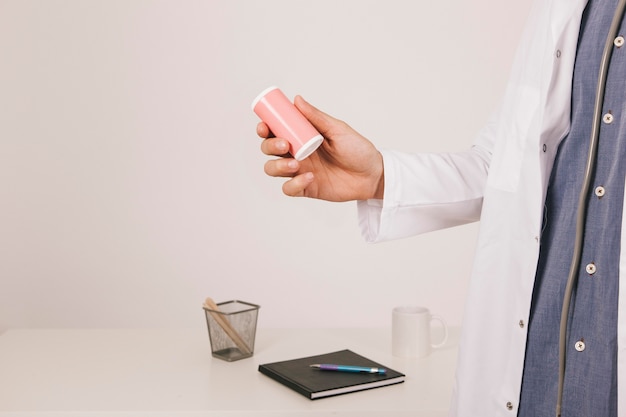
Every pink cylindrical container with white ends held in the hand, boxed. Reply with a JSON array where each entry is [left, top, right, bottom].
[[252, 86, 324, 161]]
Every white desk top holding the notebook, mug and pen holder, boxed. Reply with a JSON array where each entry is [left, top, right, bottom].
[[0, 328, 459, 417]]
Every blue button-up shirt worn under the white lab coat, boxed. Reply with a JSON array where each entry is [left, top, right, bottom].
[[518, 0, 626, 417]]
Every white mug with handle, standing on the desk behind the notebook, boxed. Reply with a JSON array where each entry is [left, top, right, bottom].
[[391, 306, 448, 358]]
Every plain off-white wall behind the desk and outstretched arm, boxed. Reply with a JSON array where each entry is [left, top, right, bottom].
[[0, 0, 529, 328]]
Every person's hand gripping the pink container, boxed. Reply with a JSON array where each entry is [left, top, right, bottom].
[[257, 96, 384, 201]]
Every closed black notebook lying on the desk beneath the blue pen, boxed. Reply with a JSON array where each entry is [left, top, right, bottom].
[[259, 350, 405, 400]]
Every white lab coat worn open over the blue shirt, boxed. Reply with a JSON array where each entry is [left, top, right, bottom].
[[358, 0, 626, 417]]
